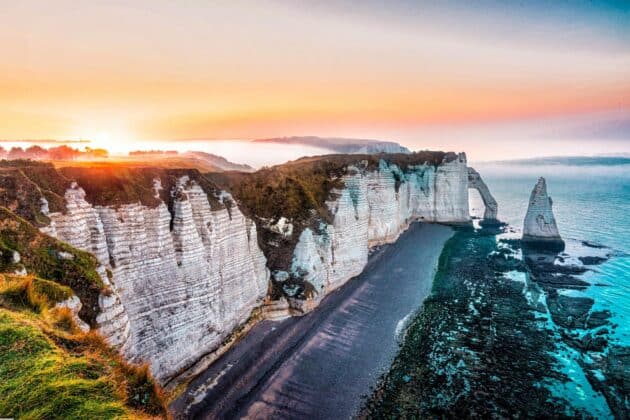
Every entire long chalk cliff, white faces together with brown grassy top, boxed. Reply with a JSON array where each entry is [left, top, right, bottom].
[[0, 152, 496, 383]]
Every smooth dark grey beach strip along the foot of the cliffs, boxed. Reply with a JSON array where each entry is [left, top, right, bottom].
[[171, 223, 453, 419]]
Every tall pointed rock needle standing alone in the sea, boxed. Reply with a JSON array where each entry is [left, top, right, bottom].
[[523, 177, 564, 251]]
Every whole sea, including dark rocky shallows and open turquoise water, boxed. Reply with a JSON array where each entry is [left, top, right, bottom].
[[362, 158, 630, 418]]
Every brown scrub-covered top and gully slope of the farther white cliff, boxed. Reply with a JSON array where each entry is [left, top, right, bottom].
[[210, 151, 458, 278]]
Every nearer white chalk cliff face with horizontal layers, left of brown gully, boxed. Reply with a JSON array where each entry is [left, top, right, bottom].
[[44, 177, 269, 381]]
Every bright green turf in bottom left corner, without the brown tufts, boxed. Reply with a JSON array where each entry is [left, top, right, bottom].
[[0, 309, 131, 419]]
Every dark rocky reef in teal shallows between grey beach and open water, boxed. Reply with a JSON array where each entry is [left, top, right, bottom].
[[362, 221, 630, 419]]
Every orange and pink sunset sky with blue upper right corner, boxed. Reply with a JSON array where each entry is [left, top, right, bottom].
[[0, 0, 630, 160]]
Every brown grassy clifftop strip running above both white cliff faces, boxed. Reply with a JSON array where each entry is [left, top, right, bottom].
[[0, 151, 457, 217]]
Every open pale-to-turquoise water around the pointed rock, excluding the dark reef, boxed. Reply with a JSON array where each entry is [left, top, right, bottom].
[[471, 165, 630, 417]]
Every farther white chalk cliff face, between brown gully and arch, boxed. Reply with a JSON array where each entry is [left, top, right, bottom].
[[274, 154, 470, 311]]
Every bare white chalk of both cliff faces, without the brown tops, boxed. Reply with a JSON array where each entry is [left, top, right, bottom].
[[33, 153, 496, 383]]
